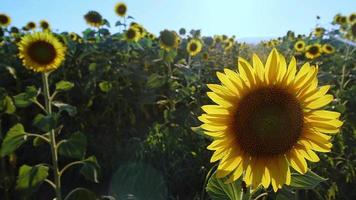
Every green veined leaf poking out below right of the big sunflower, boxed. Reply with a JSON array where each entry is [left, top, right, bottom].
[[290, 170, 327, 189]]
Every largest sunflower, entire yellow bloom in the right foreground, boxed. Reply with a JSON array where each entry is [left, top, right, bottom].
[[199, 49, 342, 191]]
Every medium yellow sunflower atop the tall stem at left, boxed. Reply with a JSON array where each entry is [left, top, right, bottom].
[[18, 32, 66, 72]]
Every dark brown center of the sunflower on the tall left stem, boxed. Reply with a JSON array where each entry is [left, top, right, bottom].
[[27, 41, 57, 65]]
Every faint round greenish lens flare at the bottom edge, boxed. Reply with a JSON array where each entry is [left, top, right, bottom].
[[110, 163, 168, 200]]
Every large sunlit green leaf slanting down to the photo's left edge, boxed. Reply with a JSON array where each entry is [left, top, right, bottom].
[[0, 124, 27, 157]]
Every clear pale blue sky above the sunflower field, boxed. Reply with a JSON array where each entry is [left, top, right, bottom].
[[0, 0, 356, 38]]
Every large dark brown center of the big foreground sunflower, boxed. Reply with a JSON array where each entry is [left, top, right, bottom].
[[235, 87, 303, 156]]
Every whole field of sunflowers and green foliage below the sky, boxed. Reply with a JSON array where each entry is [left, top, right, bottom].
[[0, 2, 356, 200]]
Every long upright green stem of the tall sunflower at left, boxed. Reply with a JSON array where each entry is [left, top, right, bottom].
[[42, 73, 62, 200]]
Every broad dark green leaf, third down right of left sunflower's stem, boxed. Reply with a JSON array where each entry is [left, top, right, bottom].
[[58, 132, 87, 159]]
